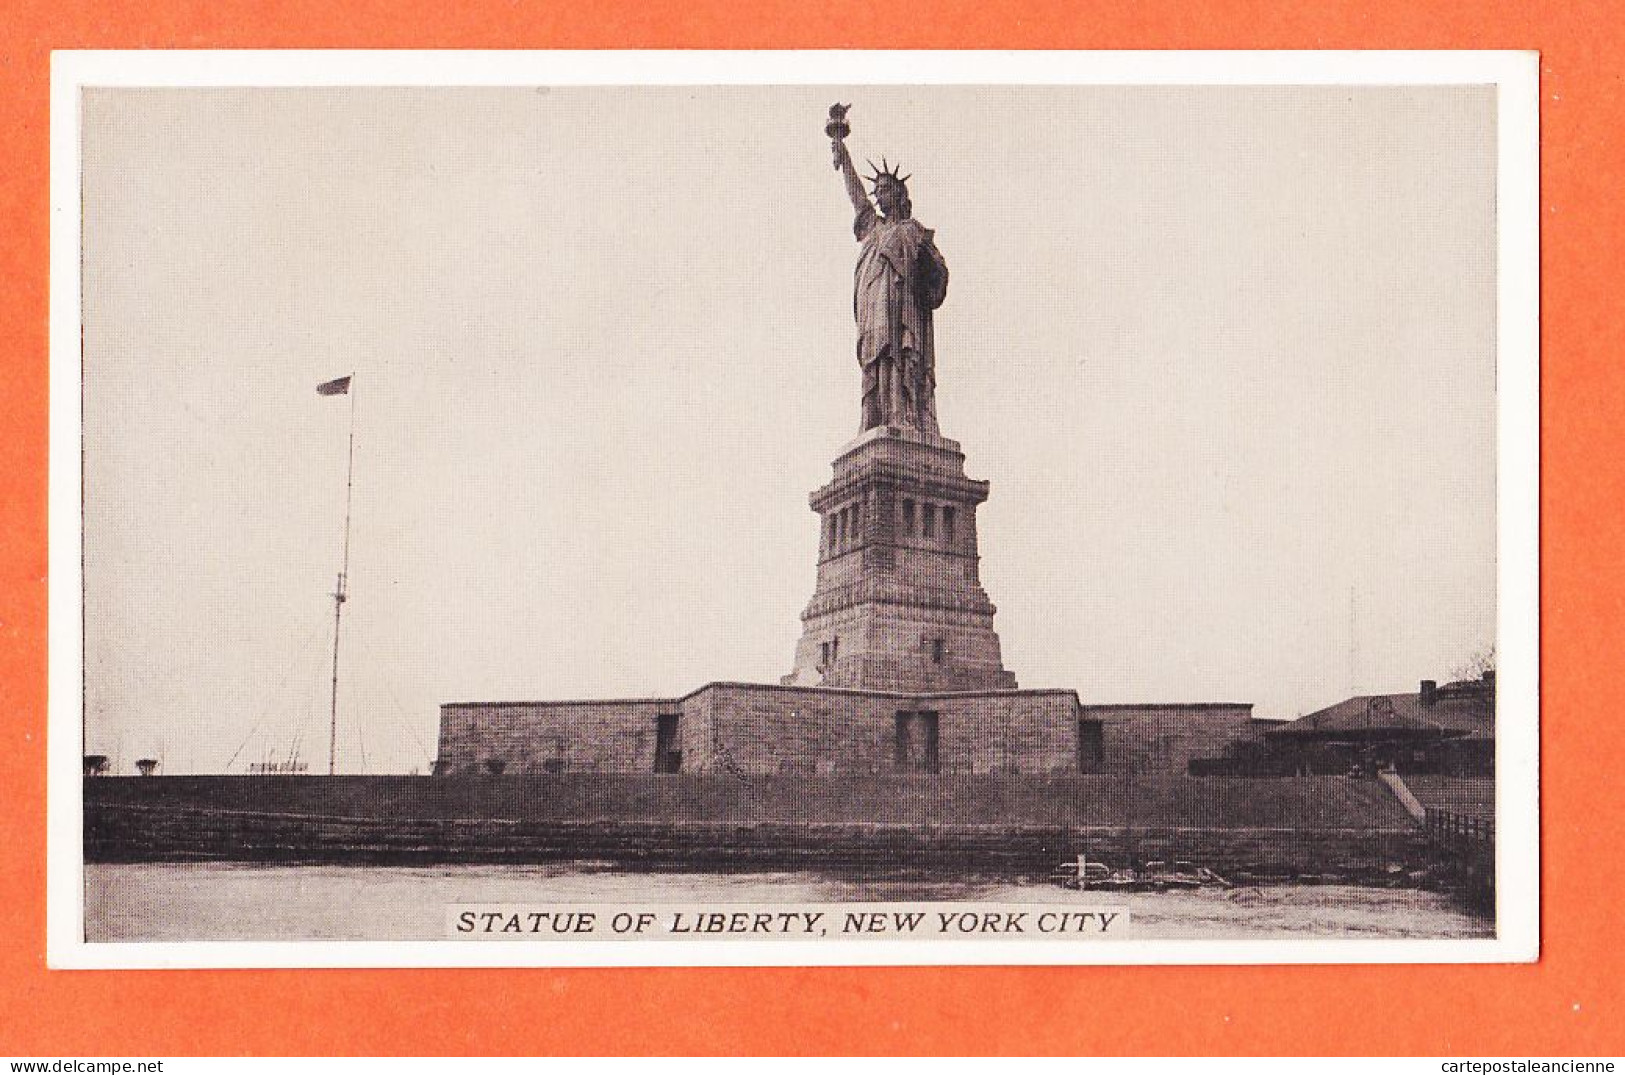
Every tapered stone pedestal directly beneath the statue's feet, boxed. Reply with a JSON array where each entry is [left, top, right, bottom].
[[783, 425, 1016, 692]]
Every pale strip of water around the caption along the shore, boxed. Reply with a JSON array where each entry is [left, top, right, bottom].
[[85, 862, 1495, 942]]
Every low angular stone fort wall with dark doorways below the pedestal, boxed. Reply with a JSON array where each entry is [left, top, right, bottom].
[[436, 682, 1255, 776]]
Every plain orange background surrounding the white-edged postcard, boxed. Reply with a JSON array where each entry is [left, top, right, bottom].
[[0, 0, 1625, 1056]]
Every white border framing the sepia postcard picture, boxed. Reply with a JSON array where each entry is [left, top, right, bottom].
[[46, 50, 1541, 968]]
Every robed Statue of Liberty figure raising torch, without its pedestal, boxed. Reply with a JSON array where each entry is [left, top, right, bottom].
[[824, 104, 947, 434]]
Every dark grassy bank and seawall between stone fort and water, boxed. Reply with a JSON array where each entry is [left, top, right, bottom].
[[85, 775, 1430, 879]]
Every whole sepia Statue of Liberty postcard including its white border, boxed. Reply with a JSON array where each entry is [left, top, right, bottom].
[[49, 52, 1541, 968]]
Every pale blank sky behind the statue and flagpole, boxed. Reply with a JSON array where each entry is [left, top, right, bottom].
[[83, 86, 1495, 773]]
